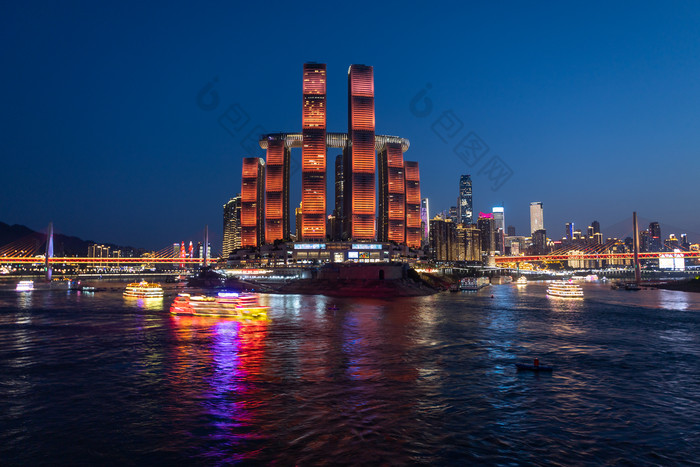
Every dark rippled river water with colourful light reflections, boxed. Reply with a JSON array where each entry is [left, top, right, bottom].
[[0, 283, 700, 465]]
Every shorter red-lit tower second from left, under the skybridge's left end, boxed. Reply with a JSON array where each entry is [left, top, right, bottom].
[[265, 139, 290, 243]]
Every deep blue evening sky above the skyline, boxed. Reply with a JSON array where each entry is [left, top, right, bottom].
[[0, 2, 700, 252]]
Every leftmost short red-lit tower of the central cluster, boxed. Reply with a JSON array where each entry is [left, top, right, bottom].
[[241, 157, 265, 248]]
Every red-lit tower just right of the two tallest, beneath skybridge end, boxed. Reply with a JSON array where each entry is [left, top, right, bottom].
[[377, 143, 406, 244]]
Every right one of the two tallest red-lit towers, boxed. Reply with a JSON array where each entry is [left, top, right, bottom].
[[344, 65, 376, 241]]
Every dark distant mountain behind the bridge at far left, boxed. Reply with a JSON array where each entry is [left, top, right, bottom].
[[0, 222, 146, 256]]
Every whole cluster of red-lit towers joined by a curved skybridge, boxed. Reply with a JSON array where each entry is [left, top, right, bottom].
[[241, 63, 424, 252]]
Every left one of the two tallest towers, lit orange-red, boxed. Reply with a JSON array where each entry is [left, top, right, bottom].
[[301, 63, 326, 241]]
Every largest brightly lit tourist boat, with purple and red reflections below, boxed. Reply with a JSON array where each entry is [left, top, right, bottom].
[[170, 292, 267, 319]]
